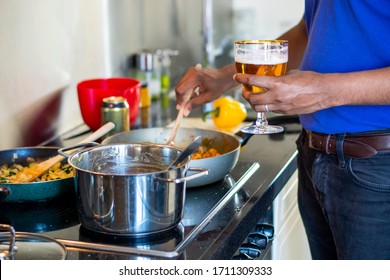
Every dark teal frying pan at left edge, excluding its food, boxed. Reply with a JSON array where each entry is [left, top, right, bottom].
[[0, 146, 75, 202]]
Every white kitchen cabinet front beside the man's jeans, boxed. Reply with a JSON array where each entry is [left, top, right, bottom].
[[272, 171, 311, 260]]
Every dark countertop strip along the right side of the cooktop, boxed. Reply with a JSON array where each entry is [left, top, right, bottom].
[[193, 126, 297, 259]]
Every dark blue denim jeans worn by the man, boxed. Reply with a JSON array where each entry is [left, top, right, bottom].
[[297, 131, 390, 260]]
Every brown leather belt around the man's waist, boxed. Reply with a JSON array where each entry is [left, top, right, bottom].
[[307, 130, 390, 158]]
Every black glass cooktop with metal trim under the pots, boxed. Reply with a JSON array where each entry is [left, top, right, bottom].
[[0, 161, 260, 259]]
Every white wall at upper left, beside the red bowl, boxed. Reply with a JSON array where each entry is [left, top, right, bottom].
[[0, 0, 109, 148]]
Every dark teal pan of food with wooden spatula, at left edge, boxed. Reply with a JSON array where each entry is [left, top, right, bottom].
[[0, 122, 114, 202]]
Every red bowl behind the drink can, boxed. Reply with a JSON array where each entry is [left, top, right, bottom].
[[77, 78, 141, 131]]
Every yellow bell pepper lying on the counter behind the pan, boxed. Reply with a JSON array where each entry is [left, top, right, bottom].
[[202, 96, 247, 129]]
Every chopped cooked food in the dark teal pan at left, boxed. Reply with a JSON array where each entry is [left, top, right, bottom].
[[0, 157, 74, 183]]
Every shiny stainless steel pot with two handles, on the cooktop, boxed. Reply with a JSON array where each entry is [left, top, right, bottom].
[[59, 144, 208, 236]]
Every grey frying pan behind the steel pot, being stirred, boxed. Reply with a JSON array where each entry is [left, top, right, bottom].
[[102, 127, 250, 187]]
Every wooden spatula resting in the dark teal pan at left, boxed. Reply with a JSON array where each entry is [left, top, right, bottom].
[[8, 122, 115, 183]]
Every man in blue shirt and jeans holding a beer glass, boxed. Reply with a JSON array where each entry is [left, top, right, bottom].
[[176, 0, 390, 259]]
